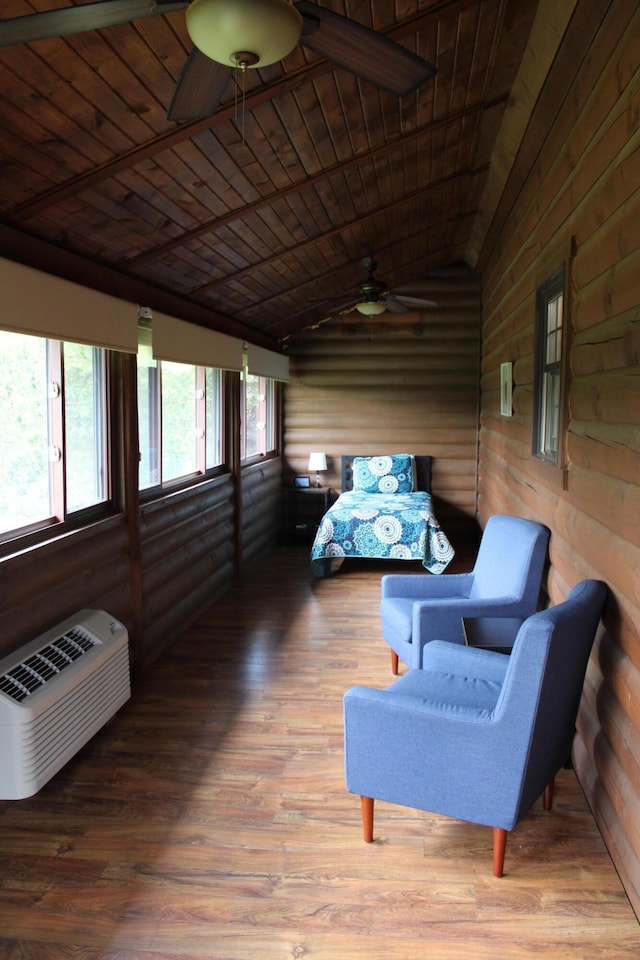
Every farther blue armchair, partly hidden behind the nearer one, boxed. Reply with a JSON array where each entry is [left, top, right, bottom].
[[380, 514, 549, 674]]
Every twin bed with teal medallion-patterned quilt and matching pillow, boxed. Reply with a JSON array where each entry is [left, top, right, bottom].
[[311, 454, 454, 577]]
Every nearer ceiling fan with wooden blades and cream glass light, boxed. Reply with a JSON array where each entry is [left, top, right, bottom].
[[0, 0, 436, 120]]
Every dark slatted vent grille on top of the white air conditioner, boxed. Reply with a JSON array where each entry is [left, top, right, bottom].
[[0, 626, 99, 703]]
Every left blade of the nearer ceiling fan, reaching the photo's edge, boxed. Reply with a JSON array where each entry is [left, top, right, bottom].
[[0, 0, 189, 47]]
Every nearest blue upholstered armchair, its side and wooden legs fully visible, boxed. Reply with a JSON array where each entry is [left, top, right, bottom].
[[344, 580, 606, 877]]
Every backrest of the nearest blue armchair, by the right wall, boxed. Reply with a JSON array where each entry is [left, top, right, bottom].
[[495, 580, 607, 819]]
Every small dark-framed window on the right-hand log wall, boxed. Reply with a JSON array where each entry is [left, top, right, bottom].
[[533, 267, 566, 466]]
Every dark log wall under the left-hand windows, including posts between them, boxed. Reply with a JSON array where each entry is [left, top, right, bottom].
[[0, 354, 281, 677]]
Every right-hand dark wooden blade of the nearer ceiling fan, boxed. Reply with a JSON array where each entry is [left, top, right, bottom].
[[294, 0, 436, 97]]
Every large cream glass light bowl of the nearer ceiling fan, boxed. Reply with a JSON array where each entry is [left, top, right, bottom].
[[185, 0, 302, 67]]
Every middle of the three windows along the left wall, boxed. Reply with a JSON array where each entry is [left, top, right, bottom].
[[138, 331, 222, 490]]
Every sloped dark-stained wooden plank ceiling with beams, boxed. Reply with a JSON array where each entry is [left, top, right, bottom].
[[0, 0, 537, 346]]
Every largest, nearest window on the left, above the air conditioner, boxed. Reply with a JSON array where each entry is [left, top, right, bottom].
[[0, 331, 110, 539]]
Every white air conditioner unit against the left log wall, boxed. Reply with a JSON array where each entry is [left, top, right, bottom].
[[0, 610, 131, 800]]
